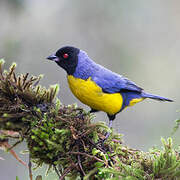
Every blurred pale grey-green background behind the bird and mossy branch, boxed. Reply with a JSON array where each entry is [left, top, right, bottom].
[[0, 0, 180, 180]]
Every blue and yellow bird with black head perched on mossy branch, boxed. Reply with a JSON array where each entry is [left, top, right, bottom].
[[47, 46, 173, 139]]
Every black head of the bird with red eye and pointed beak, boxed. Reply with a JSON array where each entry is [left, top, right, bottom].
[[47, 46, 80, 75]]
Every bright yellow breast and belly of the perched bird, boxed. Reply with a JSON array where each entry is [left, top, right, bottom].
[[67, 75, 123, 115]]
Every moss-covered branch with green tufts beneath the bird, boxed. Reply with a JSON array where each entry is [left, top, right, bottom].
[[0, 60, 180, 180]]
